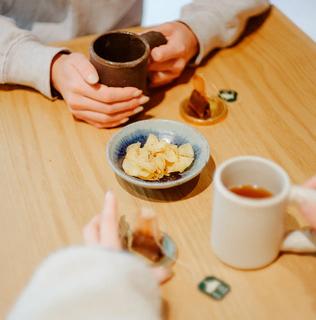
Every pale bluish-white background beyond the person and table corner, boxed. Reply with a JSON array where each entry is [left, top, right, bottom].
[[143, 0, 316, 41]]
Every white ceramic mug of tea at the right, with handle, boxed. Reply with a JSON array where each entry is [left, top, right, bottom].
[[211, 156, 316, 269]]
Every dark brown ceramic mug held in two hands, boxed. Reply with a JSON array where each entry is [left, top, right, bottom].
[[90, 31, 167, 91]]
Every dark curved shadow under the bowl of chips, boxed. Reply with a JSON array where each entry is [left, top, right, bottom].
[[116, 157, 216, 202]]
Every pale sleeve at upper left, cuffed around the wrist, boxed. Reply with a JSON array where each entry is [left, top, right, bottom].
[[0, 16, 64, 98]]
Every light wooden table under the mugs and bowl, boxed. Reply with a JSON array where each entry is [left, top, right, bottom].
[[0, 9, 316, 320]]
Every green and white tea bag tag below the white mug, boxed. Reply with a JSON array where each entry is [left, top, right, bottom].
[[198, 276, 230, 300]]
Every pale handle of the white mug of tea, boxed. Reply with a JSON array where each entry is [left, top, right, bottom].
[[281, 186, 316, 253]]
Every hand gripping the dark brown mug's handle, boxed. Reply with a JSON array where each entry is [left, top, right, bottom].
[[149, 22, 198, 87]]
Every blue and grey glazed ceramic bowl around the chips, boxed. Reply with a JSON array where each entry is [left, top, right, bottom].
[[106, 120, 210, 189]]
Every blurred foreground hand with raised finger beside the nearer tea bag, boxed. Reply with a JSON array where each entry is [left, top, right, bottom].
[[83, 191, 172, 283]]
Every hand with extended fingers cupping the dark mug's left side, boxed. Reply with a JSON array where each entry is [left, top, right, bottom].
[[51, 53, 149, 128]]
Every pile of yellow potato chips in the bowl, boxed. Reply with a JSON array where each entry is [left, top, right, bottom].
[[122, 134, 194, 181]]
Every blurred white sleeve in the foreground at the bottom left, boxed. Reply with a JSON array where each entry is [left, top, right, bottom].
[[7, 247, 160, 320]]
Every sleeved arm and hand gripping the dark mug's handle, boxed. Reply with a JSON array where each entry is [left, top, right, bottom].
[[150, 0, 269, 86]]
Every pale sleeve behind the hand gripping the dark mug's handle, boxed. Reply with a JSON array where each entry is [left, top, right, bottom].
[[180, 0, 269, 64]]
